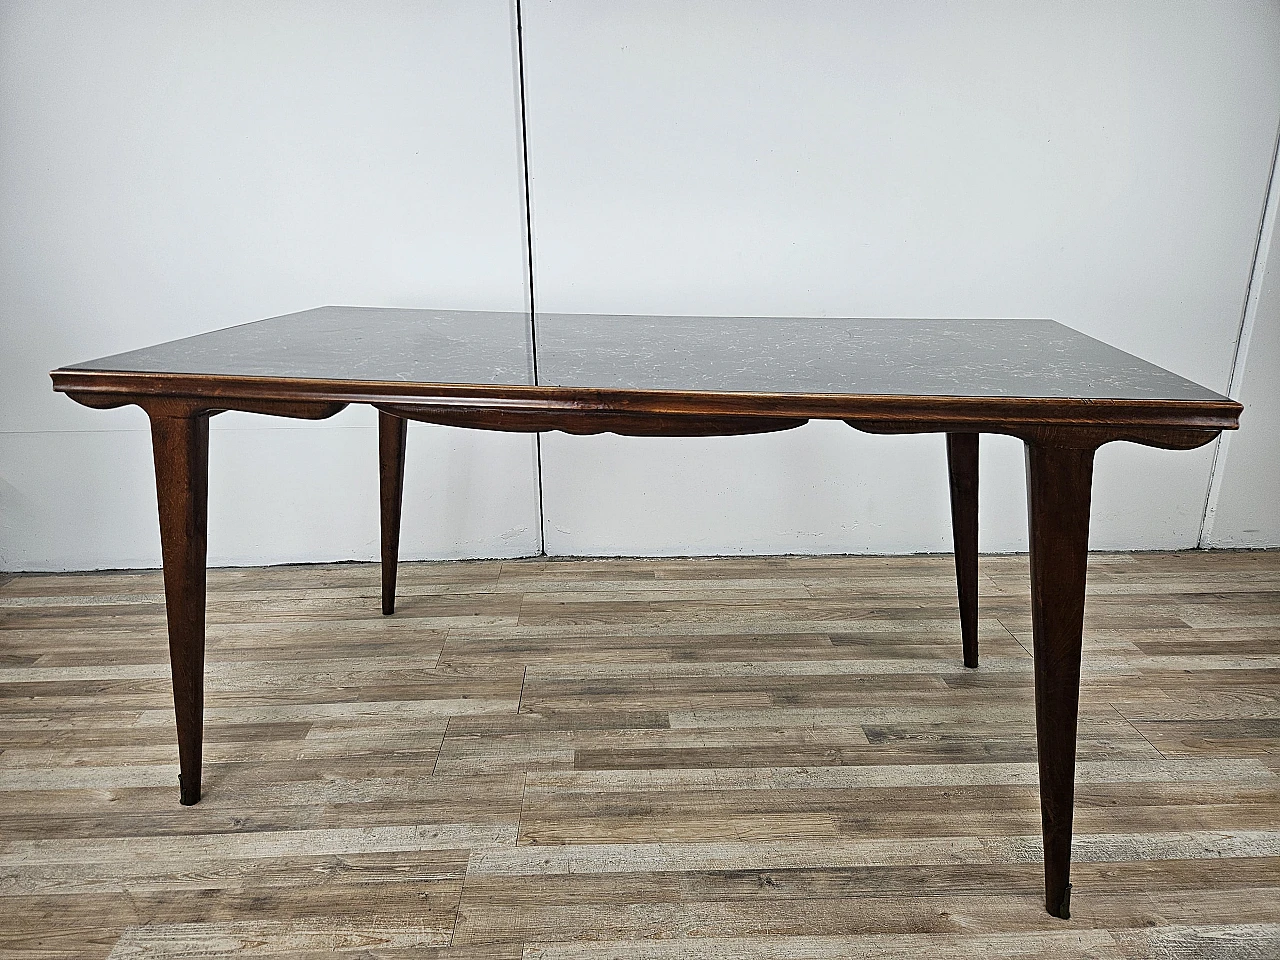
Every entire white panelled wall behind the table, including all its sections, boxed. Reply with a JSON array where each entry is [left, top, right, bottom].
[[0, 0, 1280, 570]]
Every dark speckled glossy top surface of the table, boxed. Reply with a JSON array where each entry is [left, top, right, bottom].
[[68, 307, 1225, 401]]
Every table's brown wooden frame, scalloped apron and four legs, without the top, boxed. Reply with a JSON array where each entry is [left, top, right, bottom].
[[51, 369, 1243, 919]]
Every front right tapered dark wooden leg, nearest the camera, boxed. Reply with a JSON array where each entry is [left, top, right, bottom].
[[1027, 443, 1094, 919]]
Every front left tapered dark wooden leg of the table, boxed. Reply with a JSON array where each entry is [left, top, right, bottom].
[[151, 413, 209, 806]]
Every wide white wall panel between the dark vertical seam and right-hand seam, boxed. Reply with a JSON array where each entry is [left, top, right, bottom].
[[524, 0, 1280, 554]]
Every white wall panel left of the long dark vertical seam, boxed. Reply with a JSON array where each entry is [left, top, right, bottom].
[[0, 0, 539, 570]]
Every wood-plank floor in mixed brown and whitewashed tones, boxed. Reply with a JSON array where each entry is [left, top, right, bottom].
[[0, 553, 1280, 960]]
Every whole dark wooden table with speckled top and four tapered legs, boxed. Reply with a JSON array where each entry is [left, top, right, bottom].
[[52, 307, 1242, 918]]
